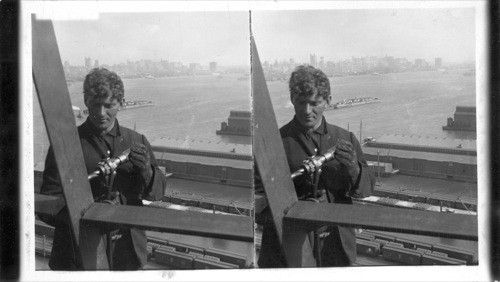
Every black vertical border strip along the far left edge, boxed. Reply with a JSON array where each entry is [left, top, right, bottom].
[[0, 0, 21, 280]]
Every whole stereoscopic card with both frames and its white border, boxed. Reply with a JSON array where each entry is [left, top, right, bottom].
[[23, 1, 489, 281]]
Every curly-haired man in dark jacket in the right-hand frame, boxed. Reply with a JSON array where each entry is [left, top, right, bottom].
[[258, 66, 375, 268]]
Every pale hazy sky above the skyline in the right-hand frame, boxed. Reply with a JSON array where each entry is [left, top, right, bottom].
[[252, 8, 476, 62]]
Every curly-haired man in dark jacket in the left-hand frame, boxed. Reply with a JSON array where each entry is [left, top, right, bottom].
[[41, 68, 166, 270]]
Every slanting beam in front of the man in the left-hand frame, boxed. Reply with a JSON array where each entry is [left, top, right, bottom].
[[32, 15, 108, 269]]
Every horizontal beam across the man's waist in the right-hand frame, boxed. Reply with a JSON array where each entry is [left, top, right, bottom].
[[285, 202, 478, 241]]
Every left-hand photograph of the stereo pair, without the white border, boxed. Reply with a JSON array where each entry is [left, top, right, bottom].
[[32, 11, 254, 270]]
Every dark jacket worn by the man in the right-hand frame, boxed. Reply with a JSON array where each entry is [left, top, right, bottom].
[[259, 118, 375, 267]]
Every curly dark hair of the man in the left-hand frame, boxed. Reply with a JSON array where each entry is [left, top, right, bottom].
[[83, 68, 125, 103]]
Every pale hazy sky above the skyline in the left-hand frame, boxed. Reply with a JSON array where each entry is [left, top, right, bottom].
[[54, 11, 250, 68]]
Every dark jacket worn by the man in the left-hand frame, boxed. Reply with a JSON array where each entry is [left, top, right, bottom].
[[41, 120, 166, 270]]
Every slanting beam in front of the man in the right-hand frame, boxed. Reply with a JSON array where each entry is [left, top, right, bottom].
[[250, 37, 316, 267]]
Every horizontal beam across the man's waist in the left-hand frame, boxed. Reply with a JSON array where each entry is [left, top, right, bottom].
[[83, 203, 253, 242]]
